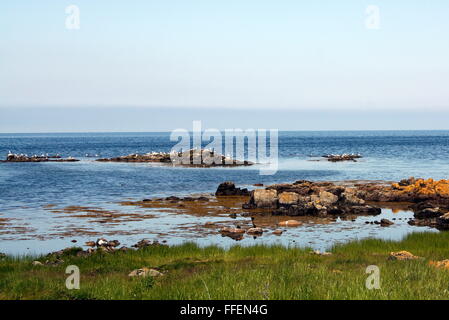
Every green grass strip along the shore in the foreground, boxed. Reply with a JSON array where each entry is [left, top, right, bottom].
[[0, 232, 449, 299]]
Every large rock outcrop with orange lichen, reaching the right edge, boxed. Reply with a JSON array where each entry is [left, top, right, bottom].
[[216, 177, 449, 230]]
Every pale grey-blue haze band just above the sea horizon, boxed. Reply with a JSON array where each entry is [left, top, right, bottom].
[[0, 106, 449, 133]]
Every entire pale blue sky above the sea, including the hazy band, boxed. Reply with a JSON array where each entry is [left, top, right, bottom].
[[0, 0, 449, 132]]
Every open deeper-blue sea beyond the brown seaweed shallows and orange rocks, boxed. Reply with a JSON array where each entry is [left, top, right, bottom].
[[0, 130, 449, 252]]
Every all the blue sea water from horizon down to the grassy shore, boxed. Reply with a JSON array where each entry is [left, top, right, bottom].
[[0, 131, 449, 253]]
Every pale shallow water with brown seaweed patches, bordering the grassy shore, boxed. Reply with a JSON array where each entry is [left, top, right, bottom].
[[0, 194, 438, 255]]
